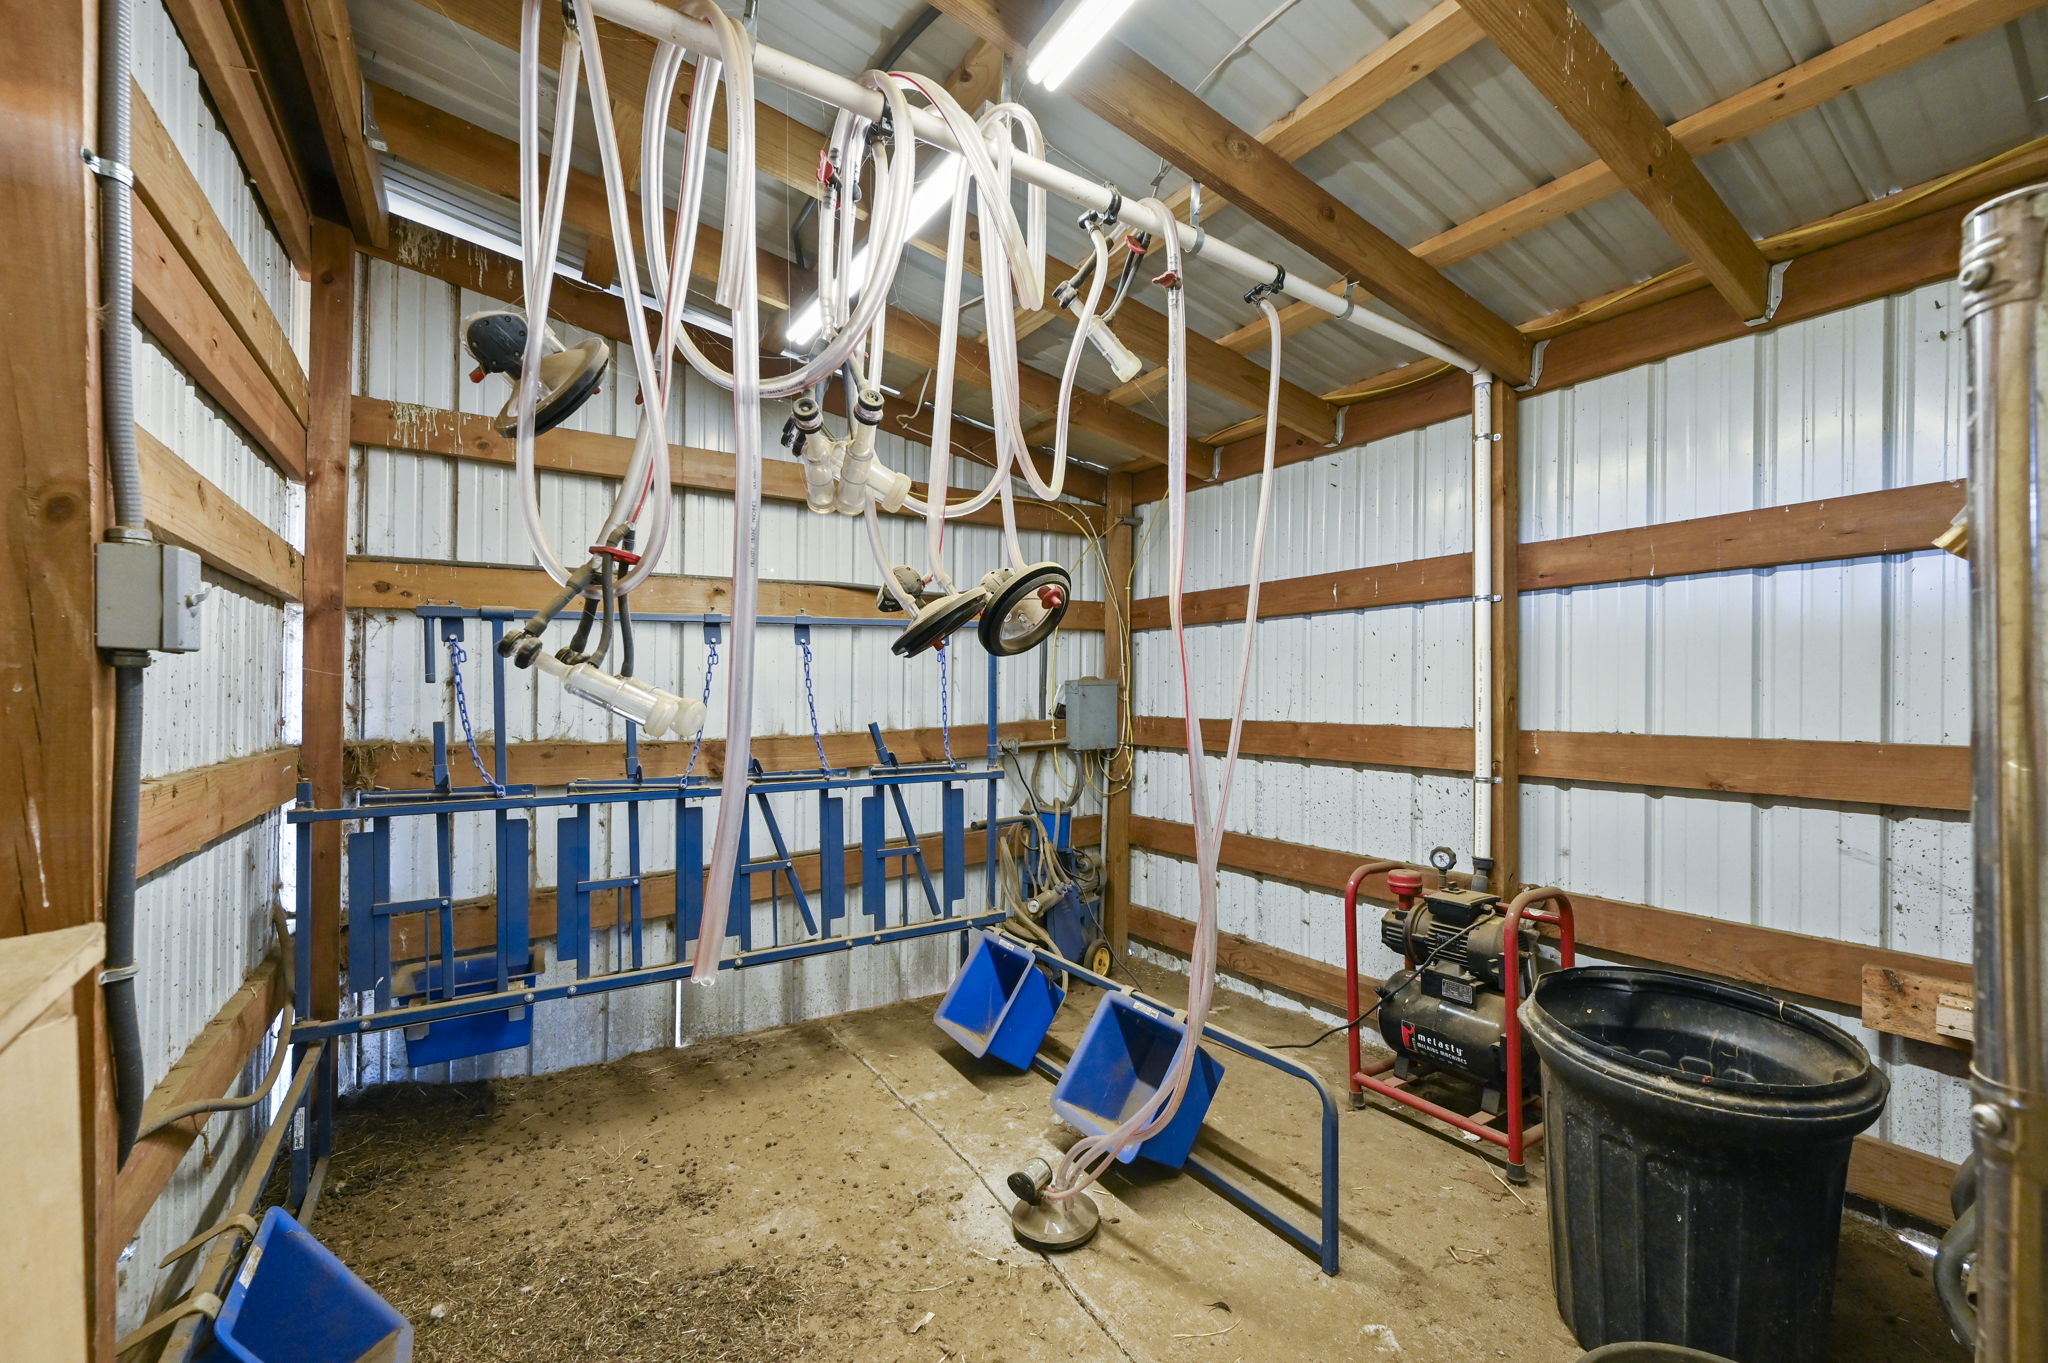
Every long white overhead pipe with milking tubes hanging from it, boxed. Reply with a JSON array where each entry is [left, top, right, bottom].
[[592, 0, 1479, 372]]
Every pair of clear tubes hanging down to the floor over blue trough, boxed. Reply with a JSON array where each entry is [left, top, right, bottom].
[[1049, 228, 1282, 1197]]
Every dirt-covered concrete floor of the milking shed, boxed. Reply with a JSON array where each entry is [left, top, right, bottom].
[[313, 972, 1966, 1363]]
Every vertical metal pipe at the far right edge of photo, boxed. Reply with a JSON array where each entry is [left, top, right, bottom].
[[1962, 186, 2048, 1363]]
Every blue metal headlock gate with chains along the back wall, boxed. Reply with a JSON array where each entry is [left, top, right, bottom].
[[287, 606, 1004, 1201]]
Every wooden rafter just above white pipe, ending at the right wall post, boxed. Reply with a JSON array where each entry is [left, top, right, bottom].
[[921, 0, 1532, 383]]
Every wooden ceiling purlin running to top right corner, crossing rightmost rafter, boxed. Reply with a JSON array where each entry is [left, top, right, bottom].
[[1415, 0, 2040, 268]]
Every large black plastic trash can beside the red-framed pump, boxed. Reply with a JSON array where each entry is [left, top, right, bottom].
[[1522, 966, 1888, 1363]]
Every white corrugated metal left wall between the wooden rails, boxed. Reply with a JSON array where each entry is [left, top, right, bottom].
[[119, 0, 305, 1330]]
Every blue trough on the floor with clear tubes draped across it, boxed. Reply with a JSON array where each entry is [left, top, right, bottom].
[[1053, 995, 1223, 1169]]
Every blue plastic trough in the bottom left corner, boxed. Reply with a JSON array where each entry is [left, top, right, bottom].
[[213, 1207, 412, 1363]]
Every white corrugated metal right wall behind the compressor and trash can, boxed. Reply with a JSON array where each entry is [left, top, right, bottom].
[[1133, 284, 1970, 1160]]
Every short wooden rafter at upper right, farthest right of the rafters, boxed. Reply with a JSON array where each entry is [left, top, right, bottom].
[[1460, 0, 1769, 317]]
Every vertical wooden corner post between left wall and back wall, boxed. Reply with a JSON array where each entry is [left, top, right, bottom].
[[299, 221, 356, 1017]]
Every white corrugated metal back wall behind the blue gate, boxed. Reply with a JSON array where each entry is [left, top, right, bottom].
[[348, 251, 1102, 1085]]
